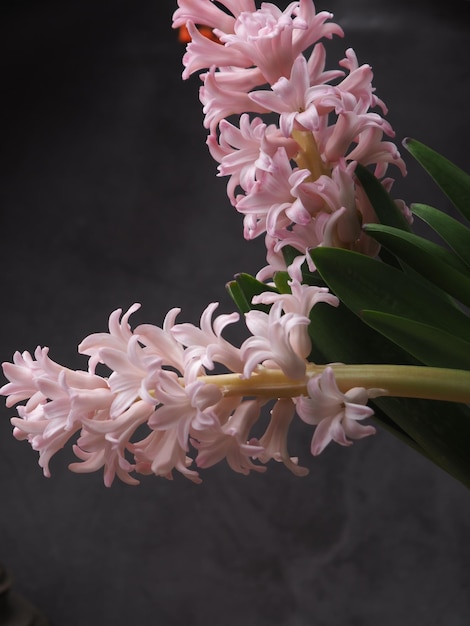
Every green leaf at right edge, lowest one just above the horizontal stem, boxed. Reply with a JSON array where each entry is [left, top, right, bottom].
[[362, 311, 470, 369]]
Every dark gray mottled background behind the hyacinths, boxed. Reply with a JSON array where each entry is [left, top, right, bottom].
[[0, 0, 470, 626]]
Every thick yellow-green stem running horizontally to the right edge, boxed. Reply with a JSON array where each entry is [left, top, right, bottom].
[[200, 364, 470, 403]]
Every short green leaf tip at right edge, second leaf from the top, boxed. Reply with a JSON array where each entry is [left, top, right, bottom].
[[411, 204, 470, 268]]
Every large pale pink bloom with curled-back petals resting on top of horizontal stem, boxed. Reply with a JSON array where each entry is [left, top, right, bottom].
[[241, 302, 310, 380]]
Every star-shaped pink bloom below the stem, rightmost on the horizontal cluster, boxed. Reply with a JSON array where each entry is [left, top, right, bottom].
[[296, 367, 375, 456]]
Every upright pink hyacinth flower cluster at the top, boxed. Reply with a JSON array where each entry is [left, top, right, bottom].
[[174, 0, 408, 280]]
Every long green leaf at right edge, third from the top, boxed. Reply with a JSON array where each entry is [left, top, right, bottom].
[[364, 224, 470, 306]]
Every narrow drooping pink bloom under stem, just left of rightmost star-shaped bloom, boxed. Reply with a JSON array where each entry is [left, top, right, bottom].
[[257, 398, 308, 476]]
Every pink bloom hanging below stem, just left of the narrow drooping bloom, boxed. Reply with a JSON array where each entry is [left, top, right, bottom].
[[192, 400, 266, 474]]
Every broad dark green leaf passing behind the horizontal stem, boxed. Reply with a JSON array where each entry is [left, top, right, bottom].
[[310, 303, 470, 487]]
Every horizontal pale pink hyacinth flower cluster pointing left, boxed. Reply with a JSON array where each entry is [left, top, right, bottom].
[[1, 287, 390, 486]]
